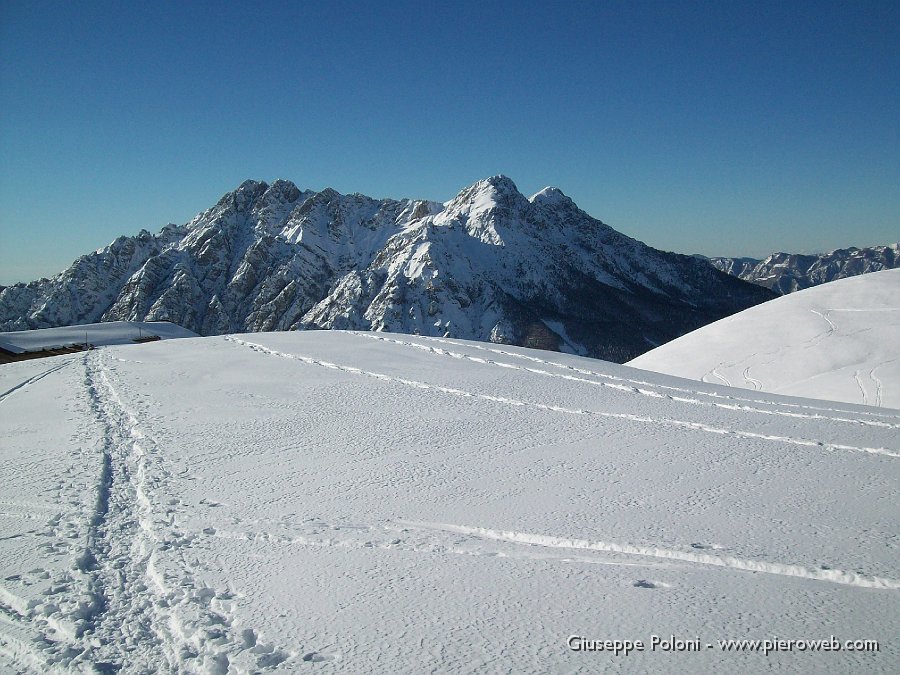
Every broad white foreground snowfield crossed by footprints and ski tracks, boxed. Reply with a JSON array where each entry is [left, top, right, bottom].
[[0, 331, 900, 673]]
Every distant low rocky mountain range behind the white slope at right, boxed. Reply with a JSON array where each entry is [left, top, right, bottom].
[[708, 244, 900, 294]]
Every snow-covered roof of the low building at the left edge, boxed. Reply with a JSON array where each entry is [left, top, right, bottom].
[[0, 321, 197, 354]]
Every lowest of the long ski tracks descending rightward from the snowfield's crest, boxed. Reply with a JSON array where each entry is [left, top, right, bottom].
[[224, 335, 900, 457]]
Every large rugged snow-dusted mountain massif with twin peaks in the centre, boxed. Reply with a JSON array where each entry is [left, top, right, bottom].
[[0, 176, 772, 361]]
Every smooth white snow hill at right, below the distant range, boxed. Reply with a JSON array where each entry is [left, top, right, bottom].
[[629, 269, 900, 409]]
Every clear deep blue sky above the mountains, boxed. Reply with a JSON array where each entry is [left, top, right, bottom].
[[0, 0, 900, 283]]
